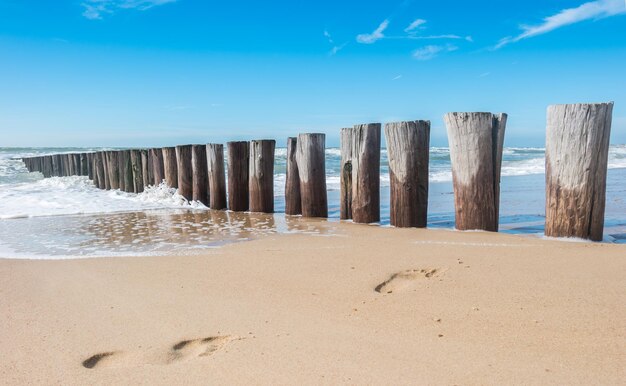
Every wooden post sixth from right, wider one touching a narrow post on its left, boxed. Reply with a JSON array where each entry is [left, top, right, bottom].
[[296, 134, 328, 217]]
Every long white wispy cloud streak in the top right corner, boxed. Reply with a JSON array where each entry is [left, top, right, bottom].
[[493, 0, 626, 50]]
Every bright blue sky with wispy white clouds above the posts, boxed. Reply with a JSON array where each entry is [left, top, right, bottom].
[[0, 0, 626, 146]]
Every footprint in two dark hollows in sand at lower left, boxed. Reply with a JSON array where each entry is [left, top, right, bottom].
[[82, 335, 234, 369]]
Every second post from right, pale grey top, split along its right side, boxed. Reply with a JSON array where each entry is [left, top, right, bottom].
[[444, 113, 507, 232]]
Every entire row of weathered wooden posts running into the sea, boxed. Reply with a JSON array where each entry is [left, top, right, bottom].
[[24, 102, 613, 240]]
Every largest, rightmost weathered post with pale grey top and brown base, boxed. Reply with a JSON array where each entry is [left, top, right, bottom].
[[545, 102, 613, 241]]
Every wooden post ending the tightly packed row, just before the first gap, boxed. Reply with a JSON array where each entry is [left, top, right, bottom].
[[247, 139, 276, 213]]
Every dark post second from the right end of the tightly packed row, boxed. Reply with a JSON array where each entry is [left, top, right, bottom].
[[227, 141, 250, 212]]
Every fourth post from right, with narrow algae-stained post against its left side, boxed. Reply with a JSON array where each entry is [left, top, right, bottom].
[[352, 123, 380, 224]]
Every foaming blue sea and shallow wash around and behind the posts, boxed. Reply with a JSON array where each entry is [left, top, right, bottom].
[[0, 145, 626, 259]]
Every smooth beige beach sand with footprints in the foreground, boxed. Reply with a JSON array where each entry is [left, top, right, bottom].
[[0, 224, 626, 385]]
